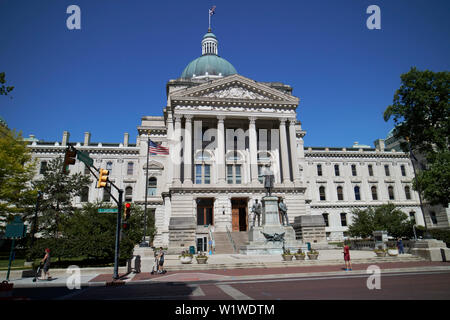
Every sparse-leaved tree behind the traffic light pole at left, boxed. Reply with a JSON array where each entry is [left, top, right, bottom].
[[33, 157, 91, 239]]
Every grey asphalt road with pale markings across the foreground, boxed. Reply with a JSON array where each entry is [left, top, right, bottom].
[[8, 272, 450, 301]]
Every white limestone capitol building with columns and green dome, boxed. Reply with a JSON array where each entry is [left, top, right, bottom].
[[28, 30, 448, 250]]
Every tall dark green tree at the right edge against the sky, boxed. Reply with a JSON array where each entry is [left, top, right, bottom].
[[384, 68, 450, 206]]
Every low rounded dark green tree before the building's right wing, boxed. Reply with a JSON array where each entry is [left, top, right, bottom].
[[348, 203, 413, 237]]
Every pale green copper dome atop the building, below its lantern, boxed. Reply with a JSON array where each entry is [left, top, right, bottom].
[[181, 54, 237, 79]]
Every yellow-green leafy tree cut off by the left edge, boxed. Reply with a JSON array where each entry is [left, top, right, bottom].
[[0, 125, 37, 228]]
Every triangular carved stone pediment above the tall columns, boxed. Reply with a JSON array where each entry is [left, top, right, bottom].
[[171, 75, 299, 104]]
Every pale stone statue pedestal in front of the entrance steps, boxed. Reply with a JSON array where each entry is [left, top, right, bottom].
[[240, 196, 302, 255]]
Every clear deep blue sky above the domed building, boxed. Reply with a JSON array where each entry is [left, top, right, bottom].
[[0, 0, 450, 147]]
